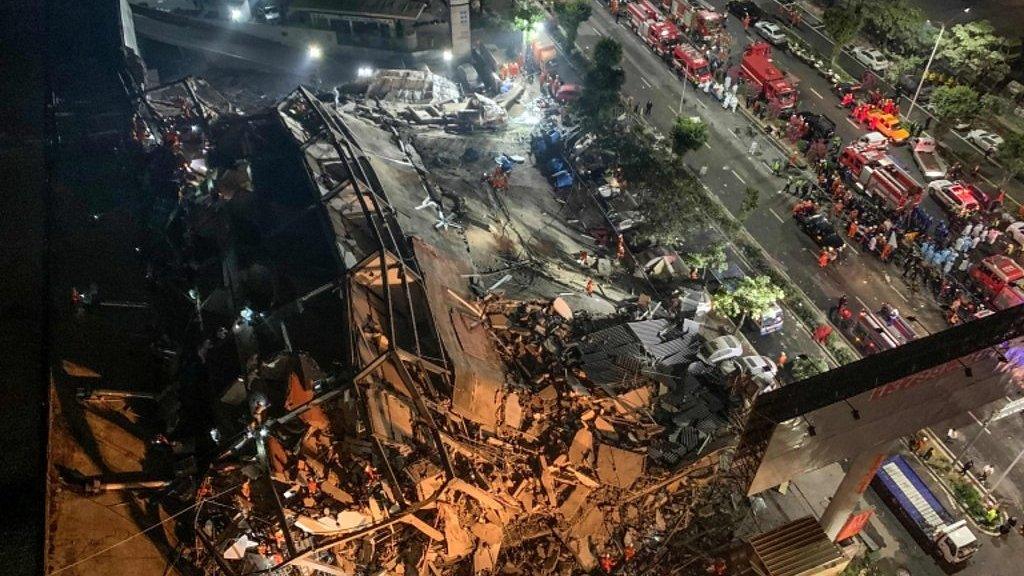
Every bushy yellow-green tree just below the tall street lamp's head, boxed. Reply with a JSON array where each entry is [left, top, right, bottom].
[[939, 20, 1010, 88]]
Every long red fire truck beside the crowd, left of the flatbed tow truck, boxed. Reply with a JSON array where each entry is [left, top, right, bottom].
[[839, 145, 925, 210]]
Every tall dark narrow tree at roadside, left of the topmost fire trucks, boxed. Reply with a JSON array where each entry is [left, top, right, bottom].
[[572, 38, 626, 133]]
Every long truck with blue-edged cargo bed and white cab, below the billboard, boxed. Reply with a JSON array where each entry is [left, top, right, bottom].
[[871, 454, 980, 568]]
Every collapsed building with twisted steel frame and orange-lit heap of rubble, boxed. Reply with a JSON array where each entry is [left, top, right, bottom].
[[114, 80, 770, 575]]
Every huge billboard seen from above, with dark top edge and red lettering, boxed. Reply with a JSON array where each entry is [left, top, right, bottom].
[[737, 306, 1024, 494]]
